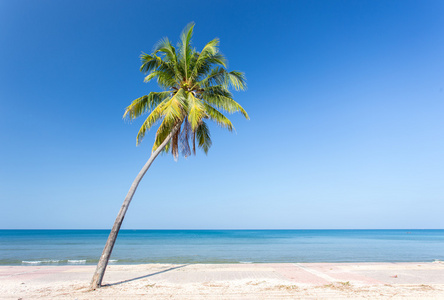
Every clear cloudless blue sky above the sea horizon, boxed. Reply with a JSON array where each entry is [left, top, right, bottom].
[[0, 0, 444, 229]]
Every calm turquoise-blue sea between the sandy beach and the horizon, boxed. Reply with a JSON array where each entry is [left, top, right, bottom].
[[0, 229, 444, 265]]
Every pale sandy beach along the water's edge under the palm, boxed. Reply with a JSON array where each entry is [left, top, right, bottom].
[[0, 262, 444, 299]]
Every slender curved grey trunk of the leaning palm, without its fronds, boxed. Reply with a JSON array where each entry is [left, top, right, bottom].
[[91, 124, 180, 289]]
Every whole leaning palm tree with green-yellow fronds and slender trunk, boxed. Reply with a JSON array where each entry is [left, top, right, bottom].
[[91, 23, 249, 289]]
